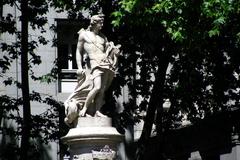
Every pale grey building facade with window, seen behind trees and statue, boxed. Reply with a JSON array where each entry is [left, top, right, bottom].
[[0, 5, 131, 160]]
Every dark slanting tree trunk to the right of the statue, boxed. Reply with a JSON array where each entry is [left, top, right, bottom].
[[136, 52, 169, 160]]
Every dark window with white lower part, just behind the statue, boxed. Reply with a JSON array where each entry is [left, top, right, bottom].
[[56, 19, 85, 93]]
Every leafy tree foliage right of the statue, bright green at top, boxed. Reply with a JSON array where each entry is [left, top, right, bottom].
[[112, 0, 239, 127]]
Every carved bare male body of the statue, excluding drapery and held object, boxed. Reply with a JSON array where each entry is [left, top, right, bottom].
[[76, 15, 109, 116]]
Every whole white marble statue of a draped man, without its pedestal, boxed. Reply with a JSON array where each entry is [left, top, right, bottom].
[[64, 14, 121, 126]]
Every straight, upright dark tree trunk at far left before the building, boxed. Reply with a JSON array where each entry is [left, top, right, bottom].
[[20, 0, 31, 160]]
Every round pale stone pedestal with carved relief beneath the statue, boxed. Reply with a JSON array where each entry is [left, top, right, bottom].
[[62, 117, 124, 160]]
